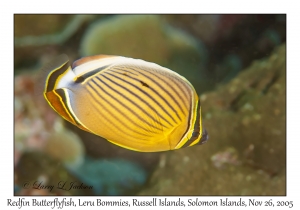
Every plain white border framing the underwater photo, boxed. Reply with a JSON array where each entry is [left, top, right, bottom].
[[0, 0, 300, 209]]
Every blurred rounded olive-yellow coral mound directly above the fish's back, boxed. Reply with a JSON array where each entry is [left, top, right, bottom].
[[80, 15, 209, 91]]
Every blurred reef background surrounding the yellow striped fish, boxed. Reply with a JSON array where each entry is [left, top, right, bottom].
[[14, 14, 286, 195]]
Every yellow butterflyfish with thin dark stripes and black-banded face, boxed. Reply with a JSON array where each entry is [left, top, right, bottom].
[[43, 55, 208, 152]]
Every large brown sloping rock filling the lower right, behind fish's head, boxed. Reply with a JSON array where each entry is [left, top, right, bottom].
[[139, 45, 286, 195]]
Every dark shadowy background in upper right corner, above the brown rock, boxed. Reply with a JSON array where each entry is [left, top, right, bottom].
[[162, 14, 286, 88]]
